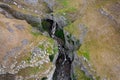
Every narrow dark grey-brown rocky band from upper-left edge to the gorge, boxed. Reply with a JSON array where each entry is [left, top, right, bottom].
[[0, 4, 41, 28]]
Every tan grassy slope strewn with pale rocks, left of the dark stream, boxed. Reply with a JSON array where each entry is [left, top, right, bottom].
[[0, 5, 57, 80]]
